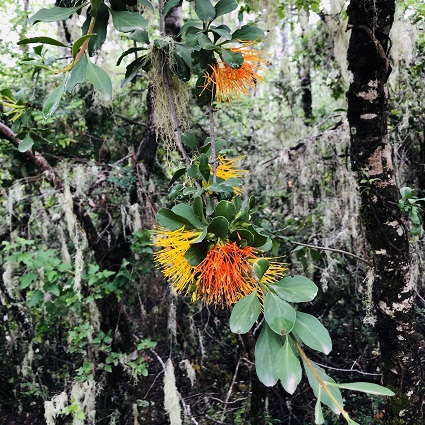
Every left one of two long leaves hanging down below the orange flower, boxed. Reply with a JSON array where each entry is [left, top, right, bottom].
[[255, 323, 282, 387]]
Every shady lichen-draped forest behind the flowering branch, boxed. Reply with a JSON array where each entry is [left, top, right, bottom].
[[0, 0, 425, 425]]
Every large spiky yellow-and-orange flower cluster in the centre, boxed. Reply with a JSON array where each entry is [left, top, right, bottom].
[[153, 228, 287, 306]]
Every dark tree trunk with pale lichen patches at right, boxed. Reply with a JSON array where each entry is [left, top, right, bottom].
[[347, 0, 423, 425]]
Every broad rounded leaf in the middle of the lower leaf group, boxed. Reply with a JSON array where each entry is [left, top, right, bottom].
[[264, 291, 297, 335]]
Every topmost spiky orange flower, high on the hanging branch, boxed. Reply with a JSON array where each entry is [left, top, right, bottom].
[[203, 43, 266, 103]]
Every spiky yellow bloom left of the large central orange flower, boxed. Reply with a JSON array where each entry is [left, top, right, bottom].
[[152, 227, 200, 293]]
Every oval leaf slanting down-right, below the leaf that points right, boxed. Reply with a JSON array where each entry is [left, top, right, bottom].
[[294, 311, 332, 354]]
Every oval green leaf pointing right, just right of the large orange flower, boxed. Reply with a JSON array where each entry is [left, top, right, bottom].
[[270, 276, 318, 303]]
